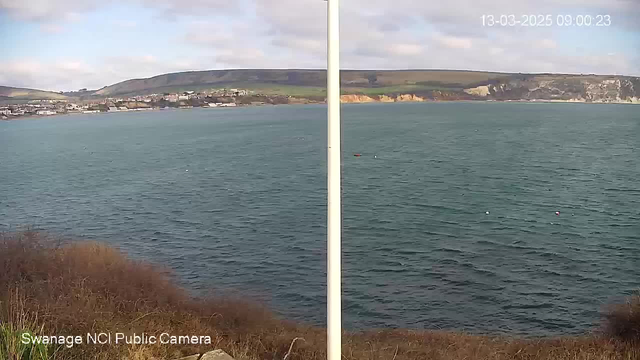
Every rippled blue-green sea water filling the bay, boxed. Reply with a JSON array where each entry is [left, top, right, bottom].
[[0, 103, 640, 335]]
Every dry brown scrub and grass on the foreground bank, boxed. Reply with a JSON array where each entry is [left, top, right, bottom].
[[0, 232, 640, 360]]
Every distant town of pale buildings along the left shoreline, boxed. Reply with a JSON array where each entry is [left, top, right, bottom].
[[0, 89, 308, 120]]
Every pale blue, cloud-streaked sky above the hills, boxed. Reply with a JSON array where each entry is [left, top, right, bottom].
[[0, 0, 640, 91]]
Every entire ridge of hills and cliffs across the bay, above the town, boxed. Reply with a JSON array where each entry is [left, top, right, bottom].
[[0, 69, 640, 103]]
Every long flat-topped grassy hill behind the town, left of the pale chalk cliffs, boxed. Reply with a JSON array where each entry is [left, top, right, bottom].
[[95, 70, 509, 96]]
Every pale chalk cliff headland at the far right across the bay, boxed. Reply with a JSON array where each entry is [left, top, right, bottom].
[[464, 75, 640, 103]]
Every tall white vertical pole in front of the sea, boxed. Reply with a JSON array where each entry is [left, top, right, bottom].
[[327, 0, 342, 360]]
